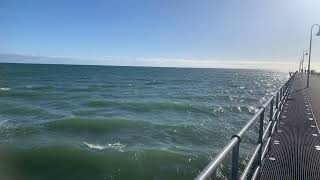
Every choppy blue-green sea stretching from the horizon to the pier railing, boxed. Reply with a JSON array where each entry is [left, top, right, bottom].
[[0, 64, 287, 180]]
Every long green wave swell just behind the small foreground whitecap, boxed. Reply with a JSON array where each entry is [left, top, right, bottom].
[[44, 118, 226, 146]]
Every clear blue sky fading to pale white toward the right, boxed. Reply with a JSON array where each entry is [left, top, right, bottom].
[[0, 0, 320, 70]]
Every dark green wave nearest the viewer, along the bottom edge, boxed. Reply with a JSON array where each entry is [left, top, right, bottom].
[[0, 146, 250, 180]]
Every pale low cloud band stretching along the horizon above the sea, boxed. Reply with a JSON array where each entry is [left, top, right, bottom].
[[0, 53, 320, 72]]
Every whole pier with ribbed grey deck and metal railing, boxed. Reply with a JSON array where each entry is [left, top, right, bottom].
[[195, 72, 320, 180]]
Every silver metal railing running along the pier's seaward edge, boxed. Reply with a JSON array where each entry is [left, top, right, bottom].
[[195, 73, 297, 180]]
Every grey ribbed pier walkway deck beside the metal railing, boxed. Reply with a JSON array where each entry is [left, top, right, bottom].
[[260, 74, 320, 180]]
